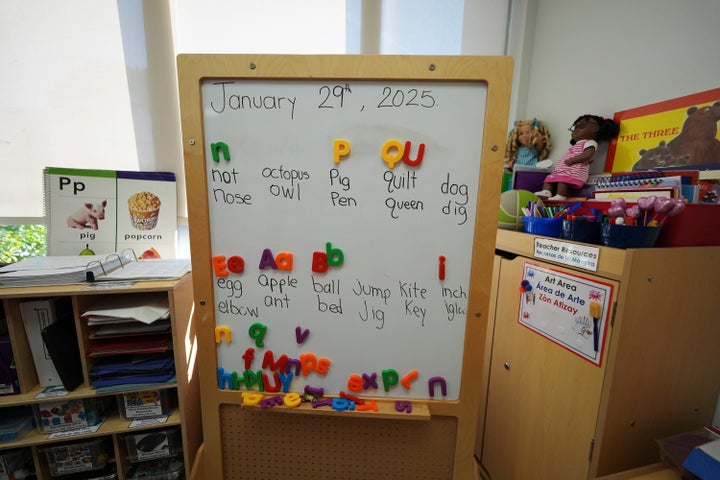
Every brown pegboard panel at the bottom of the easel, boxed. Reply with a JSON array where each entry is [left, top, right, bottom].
[[221, 405, 457, 480]]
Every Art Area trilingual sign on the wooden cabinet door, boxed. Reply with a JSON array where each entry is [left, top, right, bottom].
[[519, 262, 613, 366]]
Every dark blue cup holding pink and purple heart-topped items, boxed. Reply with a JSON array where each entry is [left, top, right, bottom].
[[601, 195, 685, 248]]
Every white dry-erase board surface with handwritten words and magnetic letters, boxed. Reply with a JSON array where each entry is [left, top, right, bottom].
[[200, 78, 486, 400]]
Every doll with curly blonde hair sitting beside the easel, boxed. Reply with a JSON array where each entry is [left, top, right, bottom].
[[505, 118, 552, 172]]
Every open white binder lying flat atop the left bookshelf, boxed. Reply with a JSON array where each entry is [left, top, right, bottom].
[[0, 249, 190, 287]]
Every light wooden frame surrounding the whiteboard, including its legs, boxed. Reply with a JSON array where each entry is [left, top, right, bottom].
[[178, 54, 513, 479]]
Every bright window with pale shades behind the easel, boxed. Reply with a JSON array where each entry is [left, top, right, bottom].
[[0, 0, 510, 258]]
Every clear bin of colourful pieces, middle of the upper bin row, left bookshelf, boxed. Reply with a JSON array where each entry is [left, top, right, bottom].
[[33, 397, 113, 433]]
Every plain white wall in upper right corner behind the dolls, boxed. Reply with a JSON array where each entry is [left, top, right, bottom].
[[513, 0, 720, 171]]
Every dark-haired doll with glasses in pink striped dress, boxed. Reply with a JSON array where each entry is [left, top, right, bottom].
[[535, 115, 620, 200]]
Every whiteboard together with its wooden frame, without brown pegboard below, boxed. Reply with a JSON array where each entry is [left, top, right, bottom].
[[178, 55, 512, 478]]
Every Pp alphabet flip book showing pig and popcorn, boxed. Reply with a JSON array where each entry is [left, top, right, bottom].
[[43, 167, 177, 258]]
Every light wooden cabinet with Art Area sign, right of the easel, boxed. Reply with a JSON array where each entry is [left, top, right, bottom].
[[476, 230, 720, 480]]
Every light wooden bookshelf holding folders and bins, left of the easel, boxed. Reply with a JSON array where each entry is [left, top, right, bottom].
[[0, 274, 202, 480]]
